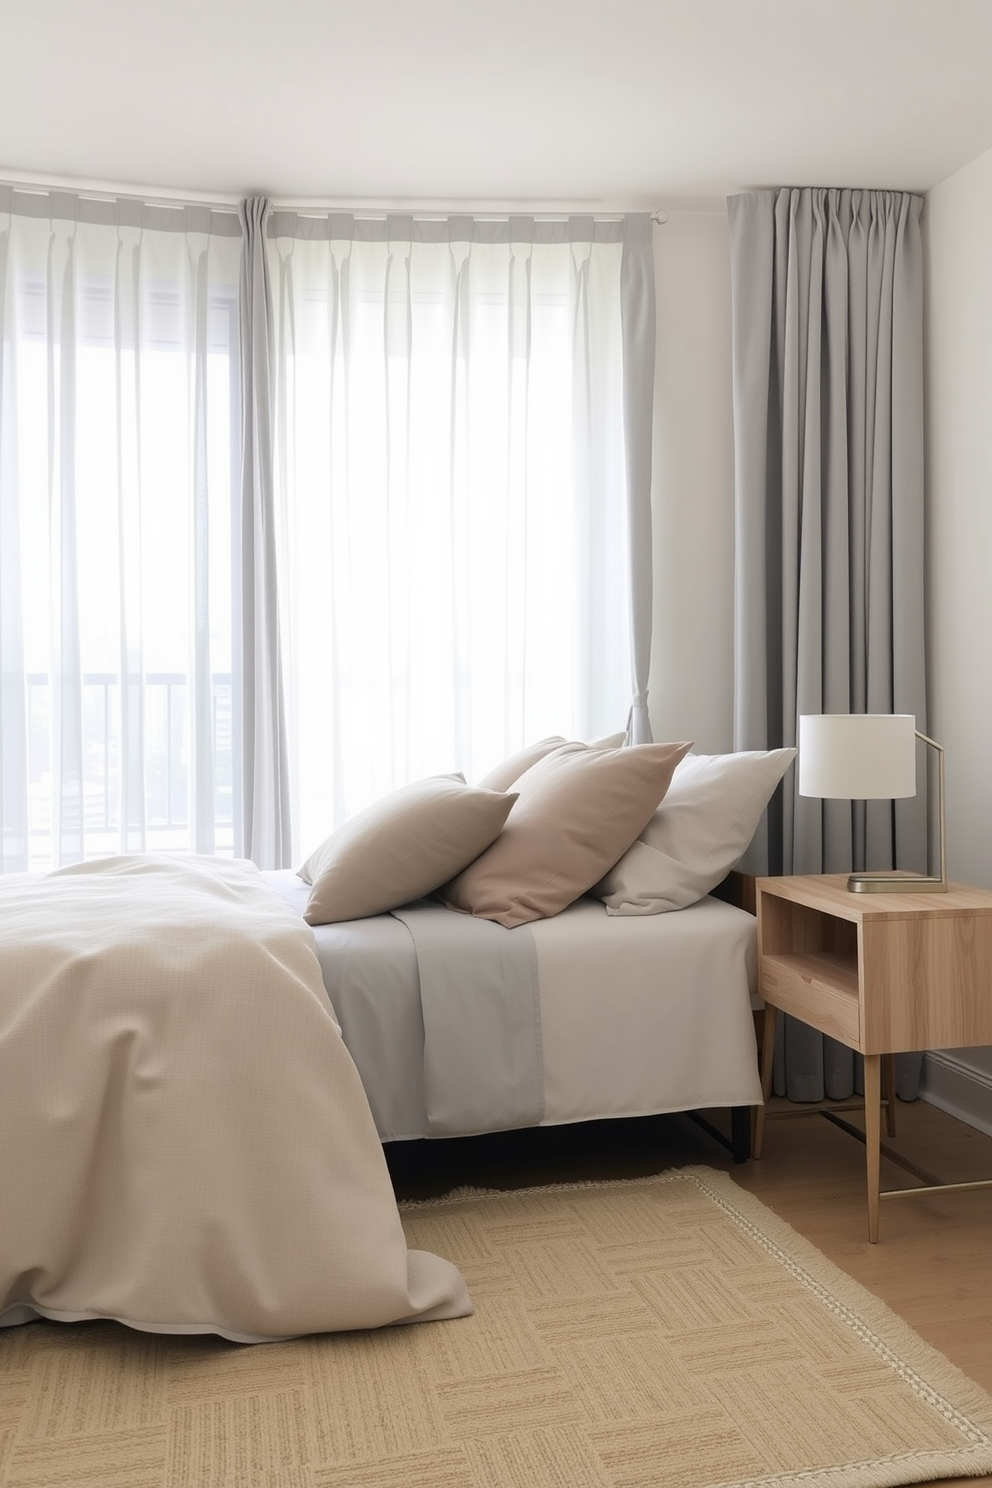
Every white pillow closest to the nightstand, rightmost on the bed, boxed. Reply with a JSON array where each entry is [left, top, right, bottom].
[[593, 748, 796, 915]]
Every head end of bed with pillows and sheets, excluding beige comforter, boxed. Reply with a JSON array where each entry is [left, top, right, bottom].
[[271, 735, 796, 1156]]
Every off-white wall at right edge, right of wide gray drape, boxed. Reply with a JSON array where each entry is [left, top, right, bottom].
[[924, 150, 992, 1131]]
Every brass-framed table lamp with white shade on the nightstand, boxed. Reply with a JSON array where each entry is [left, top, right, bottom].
[[799, 713, 947, 894]]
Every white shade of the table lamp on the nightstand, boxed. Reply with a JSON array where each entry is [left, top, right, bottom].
[[799, 713, 916, 801]]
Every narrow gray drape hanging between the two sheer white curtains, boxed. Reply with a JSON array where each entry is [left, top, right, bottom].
[[238, 196, 292, 868]]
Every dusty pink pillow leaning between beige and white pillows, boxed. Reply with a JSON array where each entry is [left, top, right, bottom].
[[440, 744, 690, 927]]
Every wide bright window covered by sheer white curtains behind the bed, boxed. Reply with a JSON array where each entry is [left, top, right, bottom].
[[0, 199, 654, 870]]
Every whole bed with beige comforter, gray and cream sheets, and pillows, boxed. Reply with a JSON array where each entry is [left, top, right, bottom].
[[0, 741, 794, 1341]]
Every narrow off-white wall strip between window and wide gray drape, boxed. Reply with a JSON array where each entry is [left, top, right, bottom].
[[648, 211, 733, 753]]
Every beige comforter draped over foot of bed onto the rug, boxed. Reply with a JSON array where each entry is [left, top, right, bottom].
[[0, 857, 471, 1341]]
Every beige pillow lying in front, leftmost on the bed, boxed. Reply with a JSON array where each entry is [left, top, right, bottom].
[[299, 775, 516, 926]]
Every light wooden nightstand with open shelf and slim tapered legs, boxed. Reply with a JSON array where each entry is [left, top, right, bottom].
[[754, 873, 992, 1242]]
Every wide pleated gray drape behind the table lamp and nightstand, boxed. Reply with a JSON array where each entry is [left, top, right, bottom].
[[727, 187, 927, 1101]]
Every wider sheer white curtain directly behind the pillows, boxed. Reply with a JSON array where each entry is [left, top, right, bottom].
[[266, 211, 653, 853]]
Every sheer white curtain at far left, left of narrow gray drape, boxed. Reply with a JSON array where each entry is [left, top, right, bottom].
[[0, 187, 241, 870]]
